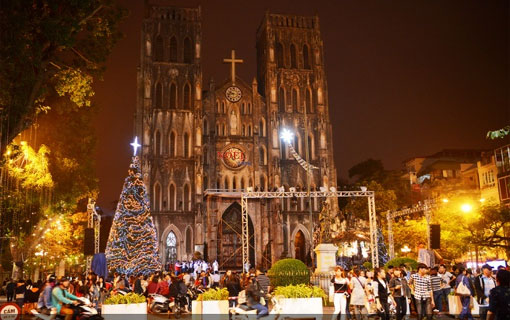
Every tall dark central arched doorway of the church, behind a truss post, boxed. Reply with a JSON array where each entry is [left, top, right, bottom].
[[218, 202, 255, 270]]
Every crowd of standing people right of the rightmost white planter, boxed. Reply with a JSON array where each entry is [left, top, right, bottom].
[[331, 263, 510, 320]]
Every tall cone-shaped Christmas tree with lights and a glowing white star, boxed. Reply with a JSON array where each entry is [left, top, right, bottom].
[[106, 139, 161, 275]]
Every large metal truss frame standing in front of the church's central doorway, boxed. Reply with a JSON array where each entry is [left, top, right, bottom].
[[204, 188, 379, 269]]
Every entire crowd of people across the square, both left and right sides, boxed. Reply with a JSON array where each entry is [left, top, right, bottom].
[[4, 261, 510, 320]]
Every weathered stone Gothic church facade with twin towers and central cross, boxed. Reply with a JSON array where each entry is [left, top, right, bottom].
[[135, 6, 336, 269]]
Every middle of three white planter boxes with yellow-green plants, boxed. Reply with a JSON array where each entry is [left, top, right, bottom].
[[191, 288, 228, 319]]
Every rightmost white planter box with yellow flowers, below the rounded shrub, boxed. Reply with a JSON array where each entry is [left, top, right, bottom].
[[274, 284, 327, 318]]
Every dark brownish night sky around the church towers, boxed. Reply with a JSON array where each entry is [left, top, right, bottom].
[[95, 0, 510, 209]]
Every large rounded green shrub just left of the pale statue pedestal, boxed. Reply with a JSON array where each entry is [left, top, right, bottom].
[[267, 259, 310, 288]]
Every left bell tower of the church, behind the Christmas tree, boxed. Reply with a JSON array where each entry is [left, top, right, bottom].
[[135, 5, 203, 263]]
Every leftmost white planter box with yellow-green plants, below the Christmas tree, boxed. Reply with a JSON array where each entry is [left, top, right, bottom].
[[101, 293, 147, 319]]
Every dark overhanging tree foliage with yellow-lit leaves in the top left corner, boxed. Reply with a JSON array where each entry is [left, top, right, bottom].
[[0, 0, 125, 151]]
